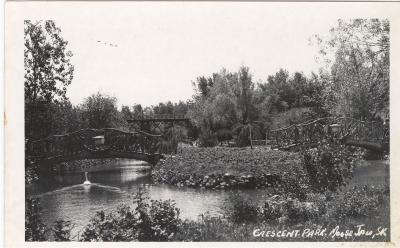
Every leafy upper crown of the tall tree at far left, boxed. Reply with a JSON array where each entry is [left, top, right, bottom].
[[24, 20, 74, 102]]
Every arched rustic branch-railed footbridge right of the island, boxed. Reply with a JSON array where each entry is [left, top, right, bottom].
[[268, 117, 390, 152]]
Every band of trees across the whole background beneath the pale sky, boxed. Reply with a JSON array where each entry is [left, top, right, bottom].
[[25, 19, 390, 146]]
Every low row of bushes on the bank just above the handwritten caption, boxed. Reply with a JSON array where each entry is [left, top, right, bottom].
[[260, 185, 389, 224]]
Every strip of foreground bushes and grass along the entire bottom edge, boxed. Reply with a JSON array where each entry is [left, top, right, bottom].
[[25, 185, 390, 241]]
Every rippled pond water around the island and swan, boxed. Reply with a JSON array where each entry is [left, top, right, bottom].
[[26, 161, 389, 238]]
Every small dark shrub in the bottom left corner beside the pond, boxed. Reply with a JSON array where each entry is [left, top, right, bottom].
[[25, 198, 48, 241]]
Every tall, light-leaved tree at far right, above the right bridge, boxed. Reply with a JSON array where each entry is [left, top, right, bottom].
[[316, 19, 390, 120]]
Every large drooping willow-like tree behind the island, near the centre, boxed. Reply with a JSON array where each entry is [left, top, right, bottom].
[[188, 67, 257, 146]]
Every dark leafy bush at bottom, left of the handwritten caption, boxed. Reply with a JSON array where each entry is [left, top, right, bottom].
[[81, 190, 180, 241]]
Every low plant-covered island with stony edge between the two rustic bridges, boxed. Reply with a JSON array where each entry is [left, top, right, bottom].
[[152, 140, 361, 194]]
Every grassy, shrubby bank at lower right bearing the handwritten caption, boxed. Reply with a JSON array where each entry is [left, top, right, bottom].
[[175, 184, 390, 241]]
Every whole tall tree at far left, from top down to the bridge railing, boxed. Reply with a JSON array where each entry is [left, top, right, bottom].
[[24, 20, 74, 139]]
